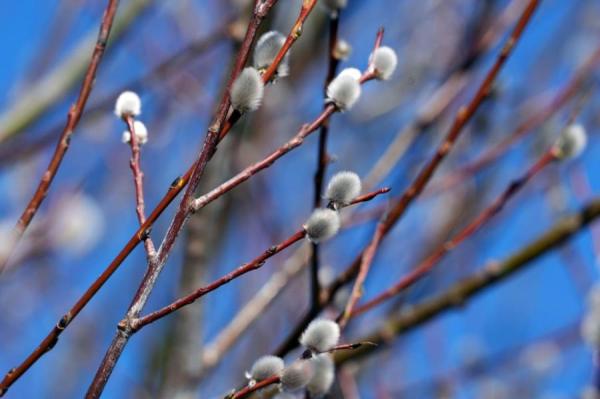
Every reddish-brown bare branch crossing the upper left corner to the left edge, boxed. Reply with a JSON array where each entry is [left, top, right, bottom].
[[0, 0, 119, 276]]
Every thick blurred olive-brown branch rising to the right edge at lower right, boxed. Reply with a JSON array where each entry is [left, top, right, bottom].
[[335, 198, 600, 364]]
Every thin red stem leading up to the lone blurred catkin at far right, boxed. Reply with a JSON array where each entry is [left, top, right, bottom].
[[349, 150, 556, 317]]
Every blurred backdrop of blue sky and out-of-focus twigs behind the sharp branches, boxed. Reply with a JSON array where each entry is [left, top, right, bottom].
[[0, 0, 600, 399]]
